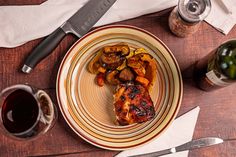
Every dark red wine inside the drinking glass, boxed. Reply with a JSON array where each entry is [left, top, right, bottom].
[[1, 89, 39, 136]]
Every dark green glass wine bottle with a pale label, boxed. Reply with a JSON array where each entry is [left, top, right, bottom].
[[194, 39, 236, 91]]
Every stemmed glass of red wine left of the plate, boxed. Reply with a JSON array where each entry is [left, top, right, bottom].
[[0, 84, 57, 140]]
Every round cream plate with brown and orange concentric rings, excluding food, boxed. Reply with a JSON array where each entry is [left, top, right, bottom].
[[56, 25, 183, 150]]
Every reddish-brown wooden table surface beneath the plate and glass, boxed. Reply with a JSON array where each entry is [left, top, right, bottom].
[[0, 0, 236, 157]]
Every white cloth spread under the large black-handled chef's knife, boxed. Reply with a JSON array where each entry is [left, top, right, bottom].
[[0, 0, 178, 47]]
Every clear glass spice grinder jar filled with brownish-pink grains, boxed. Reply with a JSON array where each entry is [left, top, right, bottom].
[[169, 0, 211, 37]]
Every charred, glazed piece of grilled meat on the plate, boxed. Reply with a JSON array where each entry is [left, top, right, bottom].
[[114, 84, 155, 125]]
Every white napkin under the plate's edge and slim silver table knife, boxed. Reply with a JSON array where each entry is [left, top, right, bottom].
[[116, 107, 200, 157]]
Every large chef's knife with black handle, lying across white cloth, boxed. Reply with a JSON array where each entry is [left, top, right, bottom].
[[21, 0, 116, 73]]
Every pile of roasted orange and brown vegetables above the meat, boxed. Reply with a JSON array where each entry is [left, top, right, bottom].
[[88, 44, 157, 91]]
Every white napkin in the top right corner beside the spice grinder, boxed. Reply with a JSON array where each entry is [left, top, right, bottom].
[[205, 0, 236, 34]]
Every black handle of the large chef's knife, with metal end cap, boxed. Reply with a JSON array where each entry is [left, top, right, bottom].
[[21, 27, 66, 73]]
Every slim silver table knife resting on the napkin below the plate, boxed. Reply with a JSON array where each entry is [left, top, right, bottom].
[[130, 137, 224, 157]]
